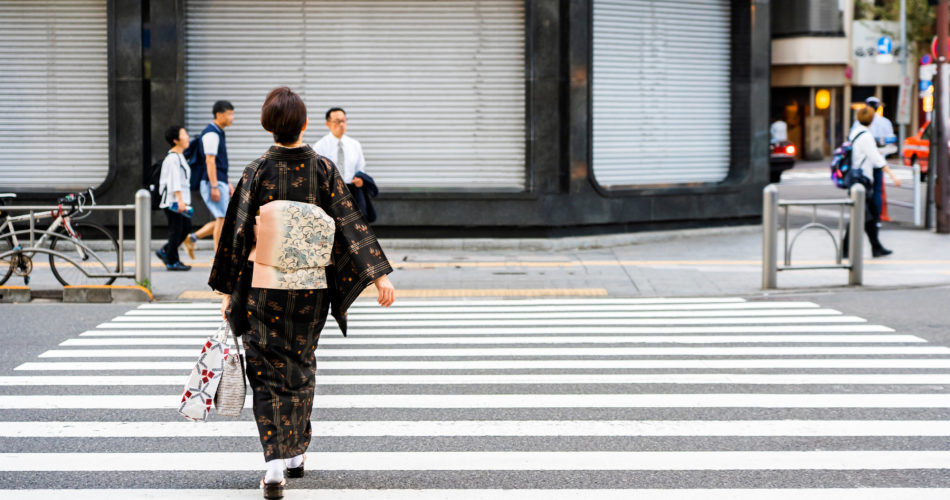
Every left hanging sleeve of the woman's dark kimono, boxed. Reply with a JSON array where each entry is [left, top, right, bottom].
[[208, 160, 260, 294]]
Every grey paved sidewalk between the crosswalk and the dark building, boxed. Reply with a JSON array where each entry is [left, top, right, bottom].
[[117, 223, 950, 300]]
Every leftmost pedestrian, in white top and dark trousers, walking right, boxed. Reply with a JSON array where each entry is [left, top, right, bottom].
[[155, 125, 191, 271]]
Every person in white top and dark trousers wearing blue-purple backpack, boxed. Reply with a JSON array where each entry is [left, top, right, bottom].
[[843, 106, 901, 257]]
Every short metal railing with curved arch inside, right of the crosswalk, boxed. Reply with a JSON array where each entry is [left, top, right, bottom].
[[762, 184, 866, 289]]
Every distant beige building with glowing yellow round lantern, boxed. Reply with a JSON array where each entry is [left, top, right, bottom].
[[769, 0, 919, 159]]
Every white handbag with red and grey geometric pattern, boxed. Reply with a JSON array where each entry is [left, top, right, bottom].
[[178, 321, 231, 422]]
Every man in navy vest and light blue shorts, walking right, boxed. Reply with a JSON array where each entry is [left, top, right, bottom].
[[185, 101, 234, 254]]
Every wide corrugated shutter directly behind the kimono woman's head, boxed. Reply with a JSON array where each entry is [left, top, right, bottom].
[[185, 0, 525, 191]]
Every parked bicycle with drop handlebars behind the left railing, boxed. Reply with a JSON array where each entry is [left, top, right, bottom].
[[0, 188, 119, 286]]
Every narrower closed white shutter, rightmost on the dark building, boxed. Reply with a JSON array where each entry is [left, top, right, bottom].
[[592, 0, 731, 186]]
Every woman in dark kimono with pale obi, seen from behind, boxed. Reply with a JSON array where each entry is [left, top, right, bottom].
[[208, 87, 395, 498]]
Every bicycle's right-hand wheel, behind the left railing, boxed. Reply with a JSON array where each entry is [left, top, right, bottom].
[[49, 222, 119, 286]]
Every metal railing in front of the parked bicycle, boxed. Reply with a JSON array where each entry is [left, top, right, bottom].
[[2, 189, 152, 283]]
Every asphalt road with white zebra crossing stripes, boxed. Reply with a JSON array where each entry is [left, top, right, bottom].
[[0, 287, 950, 498]]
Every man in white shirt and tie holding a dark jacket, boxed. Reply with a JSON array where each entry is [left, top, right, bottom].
[[313, 108, 379, 222]]
